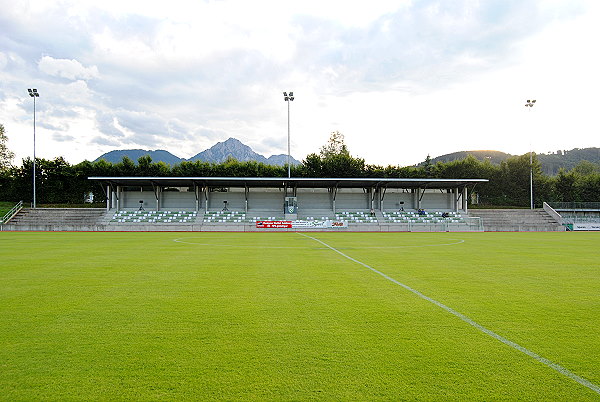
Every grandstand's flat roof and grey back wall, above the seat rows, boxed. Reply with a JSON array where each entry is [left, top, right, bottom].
[[88, 177, 488, 215]]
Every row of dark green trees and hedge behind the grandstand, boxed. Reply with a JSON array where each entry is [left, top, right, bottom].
[[0, 132, 600, 207]]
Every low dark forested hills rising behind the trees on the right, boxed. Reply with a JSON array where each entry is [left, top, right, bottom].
[[426, 148, 600, 175]]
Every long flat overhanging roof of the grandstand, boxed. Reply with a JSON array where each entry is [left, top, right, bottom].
[[88, 177, 488, 189]]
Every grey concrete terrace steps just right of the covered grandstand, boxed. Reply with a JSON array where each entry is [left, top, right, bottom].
[[469, 209, 565, 232]]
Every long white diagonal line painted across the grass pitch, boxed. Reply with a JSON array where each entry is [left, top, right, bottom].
[[298, 233, 600, 394]]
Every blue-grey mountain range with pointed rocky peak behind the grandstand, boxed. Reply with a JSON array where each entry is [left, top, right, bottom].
[[96, 138, 300, 166]]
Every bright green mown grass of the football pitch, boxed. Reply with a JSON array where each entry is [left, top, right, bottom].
[[0, 232, 600, 400]]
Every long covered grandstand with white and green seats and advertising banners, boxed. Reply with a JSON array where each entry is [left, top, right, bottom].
[[4, 177, 512, 231]]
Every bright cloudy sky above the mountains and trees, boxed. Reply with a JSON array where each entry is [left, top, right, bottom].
[[0, 0, 600, 165]]
